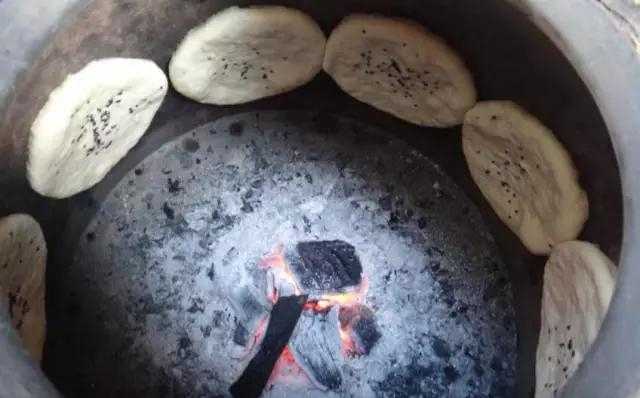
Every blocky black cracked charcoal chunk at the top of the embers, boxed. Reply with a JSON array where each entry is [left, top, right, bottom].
[[289, 240, 362, 292]]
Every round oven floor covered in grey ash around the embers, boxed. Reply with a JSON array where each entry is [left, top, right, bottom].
[[45, 111, 516, 397]]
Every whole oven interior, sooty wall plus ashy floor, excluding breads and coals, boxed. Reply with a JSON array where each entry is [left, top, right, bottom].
[[0, 0, 622, 396]]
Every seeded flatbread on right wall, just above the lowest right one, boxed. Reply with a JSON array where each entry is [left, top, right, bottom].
[[462, 101, 589, 255]]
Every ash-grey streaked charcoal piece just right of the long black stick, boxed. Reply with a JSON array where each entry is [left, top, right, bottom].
[[289, 309, 343, 390]]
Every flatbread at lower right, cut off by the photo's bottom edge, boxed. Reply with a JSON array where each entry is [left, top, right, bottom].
[[536, 241, 616, 398]]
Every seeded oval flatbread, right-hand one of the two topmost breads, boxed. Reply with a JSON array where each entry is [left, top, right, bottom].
[[323, 14, 476, 127]]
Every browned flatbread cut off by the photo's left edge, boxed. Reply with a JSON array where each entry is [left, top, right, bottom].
[[0, 214, 47, 362]]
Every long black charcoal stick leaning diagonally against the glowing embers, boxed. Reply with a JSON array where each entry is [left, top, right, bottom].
[[229, 296, 307, 398]]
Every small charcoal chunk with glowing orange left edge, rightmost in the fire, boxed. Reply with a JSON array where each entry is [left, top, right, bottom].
[[339, 304, 380, 355]]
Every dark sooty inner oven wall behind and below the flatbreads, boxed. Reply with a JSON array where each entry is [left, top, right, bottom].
[[0, 0, 622, 395]]
